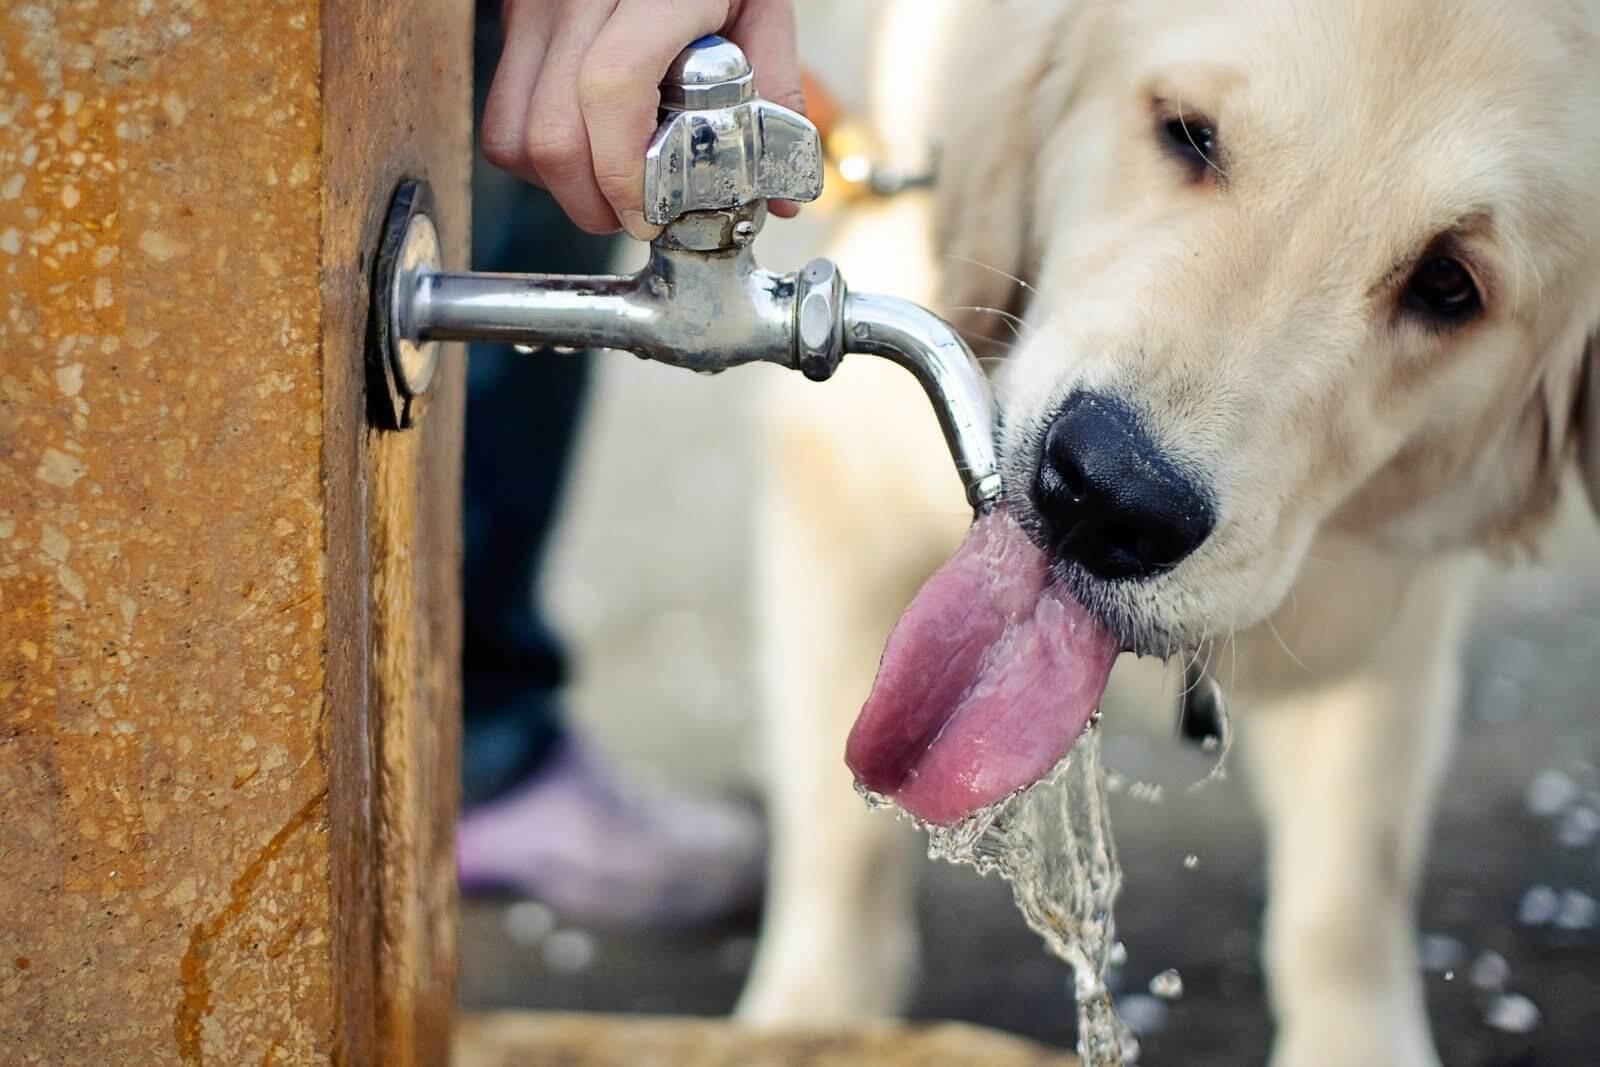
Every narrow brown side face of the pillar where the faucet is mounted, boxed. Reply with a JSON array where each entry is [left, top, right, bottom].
[[322, 0, 474, 1067]]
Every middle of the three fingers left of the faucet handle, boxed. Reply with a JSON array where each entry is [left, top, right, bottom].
[[523, 0, 618, 234]]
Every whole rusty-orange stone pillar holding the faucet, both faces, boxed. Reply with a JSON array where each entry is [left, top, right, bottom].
[[0, 0, 472, 1065]]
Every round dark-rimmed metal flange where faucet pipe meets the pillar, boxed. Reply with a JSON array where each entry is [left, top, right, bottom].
[[366, 179, 445, 430]]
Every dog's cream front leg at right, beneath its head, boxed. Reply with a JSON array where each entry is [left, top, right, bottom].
[[1240, 563, 1470, 1067]]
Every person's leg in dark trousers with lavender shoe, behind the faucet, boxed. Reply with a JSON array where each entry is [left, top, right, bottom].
[[456, 11, 765, 923]]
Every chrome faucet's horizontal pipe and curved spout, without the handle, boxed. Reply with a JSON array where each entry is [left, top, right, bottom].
[[389, 211, 1000, 514]]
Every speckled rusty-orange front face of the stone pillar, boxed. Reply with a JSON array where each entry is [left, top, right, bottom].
[[0, 0, 334, 1064]]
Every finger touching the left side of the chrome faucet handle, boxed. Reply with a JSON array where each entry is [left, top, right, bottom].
[[579, 0, 734, 240]]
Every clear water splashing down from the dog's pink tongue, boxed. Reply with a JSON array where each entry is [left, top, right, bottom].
[[864, 726, 1138, 1067]]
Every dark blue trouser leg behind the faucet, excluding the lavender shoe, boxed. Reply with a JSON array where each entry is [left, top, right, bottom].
[[462, 11, 611, 805]]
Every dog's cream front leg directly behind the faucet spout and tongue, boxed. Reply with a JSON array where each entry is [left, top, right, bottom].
[[738, 347, 970, 1022]]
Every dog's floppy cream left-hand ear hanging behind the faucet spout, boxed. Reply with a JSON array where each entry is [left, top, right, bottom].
[[934, 0, 1083, 347]]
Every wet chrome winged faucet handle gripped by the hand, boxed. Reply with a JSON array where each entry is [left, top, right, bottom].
[[645, 35, 822, 226]]
